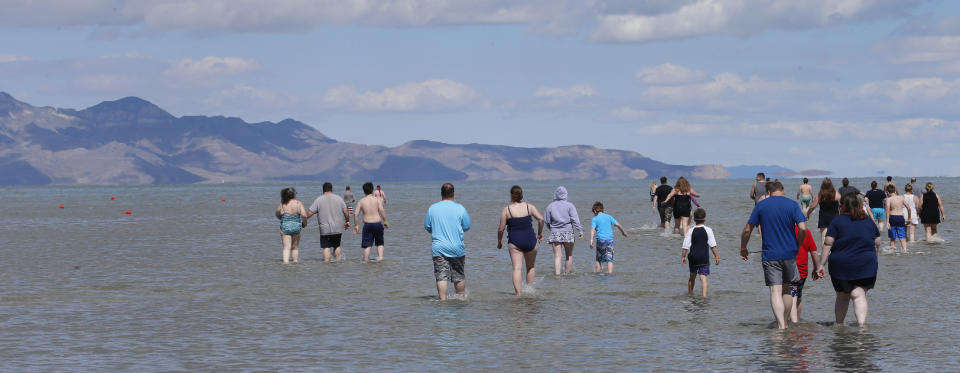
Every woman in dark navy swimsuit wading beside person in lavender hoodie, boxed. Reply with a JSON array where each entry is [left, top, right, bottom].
[[497, 185, 543, 296]]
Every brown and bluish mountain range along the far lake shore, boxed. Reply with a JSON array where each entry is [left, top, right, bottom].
[[0, 92, 730, 185]]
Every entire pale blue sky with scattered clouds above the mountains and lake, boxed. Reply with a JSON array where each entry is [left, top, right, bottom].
[[0, 0, 960, 176]]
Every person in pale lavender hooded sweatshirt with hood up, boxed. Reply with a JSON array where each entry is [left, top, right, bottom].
[[543, 186, 583, 275]]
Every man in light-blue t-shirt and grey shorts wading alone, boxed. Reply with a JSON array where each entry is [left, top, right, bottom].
[[423, 183, 470, 300]]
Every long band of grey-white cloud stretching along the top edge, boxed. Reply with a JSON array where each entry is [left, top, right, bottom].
[[0, 0, 920, 42]]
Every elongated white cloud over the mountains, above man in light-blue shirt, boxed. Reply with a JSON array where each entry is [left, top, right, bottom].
[[322, 79, 480, 112]]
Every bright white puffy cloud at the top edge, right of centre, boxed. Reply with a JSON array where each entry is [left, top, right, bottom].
[[593, 0, 918, 43]]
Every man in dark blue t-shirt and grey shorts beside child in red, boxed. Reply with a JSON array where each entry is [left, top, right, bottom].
[[740, 181, 807, 329]]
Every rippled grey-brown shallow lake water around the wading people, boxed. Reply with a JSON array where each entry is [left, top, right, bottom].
[[0, 179, 960, 371]]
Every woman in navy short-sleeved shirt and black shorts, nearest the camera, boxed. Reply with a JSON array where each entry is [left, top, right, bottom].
[[817, 194, 880, 326]]
